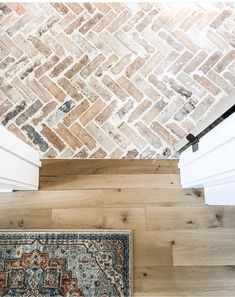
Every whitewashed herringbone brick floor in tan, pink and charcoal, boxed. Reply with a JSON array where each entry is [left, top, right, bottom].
[[0, 3, 235, 158]]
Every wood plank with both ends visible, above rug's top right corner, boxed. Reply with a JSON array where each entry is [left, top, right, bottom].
[[52, 208, 145, 230]]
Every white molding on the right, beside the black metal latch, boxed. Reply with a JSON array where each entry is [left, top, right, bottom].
[[179, 113, 235, 205]]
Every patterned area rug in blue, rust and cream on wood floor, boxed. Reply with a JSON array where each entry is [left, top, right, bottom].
[[0, 231, 132, 297]]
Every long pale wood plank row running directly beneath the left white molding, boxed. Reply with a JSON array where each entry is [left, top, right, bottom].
[[0, 189, 204, 209]]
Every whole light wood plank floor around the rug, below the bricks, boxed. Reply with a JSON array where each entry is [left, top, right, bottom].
[[0, 160, 235, 297]]
